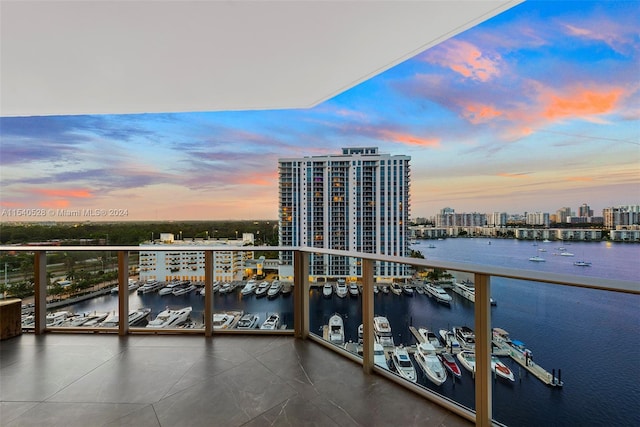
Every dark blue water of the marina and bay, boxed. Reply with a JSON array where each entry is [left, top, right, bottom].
[[61, 239, 640, 426]]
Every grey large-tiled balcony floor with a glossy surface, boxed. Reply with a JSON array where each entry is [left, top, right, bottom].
[[0, 334, 472, 427]]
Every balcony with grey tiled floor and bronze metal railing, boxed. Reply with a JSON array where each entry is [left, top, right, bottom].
[[0, 246, 640, 426]]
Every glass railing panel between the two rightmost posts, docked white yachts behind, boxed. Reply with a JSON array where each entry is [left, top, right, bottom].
[[374, 264, 475, 408]]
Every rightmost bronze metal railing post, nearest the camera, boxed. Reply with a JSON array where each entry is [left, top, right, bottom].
[[474, 273, 493, 427]]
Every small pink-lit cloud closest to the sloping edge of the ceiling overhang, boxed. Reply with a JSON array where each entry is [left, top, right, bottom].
[[423, 39, 501, 82]]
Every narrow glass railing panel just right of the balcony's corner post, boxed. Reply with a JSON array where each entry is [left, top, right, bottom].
[[309, 257, 363, 357]]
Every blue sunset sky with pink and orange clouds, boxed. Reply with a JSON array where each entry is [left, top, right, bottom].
[[0, 1, 640, 221]]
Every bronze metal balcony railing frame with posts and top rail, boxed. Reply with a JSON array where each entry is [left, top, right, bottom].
[[0, 245, 640, 426]]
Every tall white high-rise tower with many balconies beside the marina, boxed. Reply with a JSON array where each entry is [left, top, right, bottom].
[[278, 147, 411, 278]]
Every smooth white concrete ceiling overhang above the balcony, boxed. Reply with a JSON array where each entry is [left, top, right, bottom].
[[0, 0, 521, 116]]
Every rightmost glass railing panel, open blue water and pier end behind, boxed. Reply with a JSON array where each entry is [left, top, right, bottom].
[[491, 277, 640, 425]]
